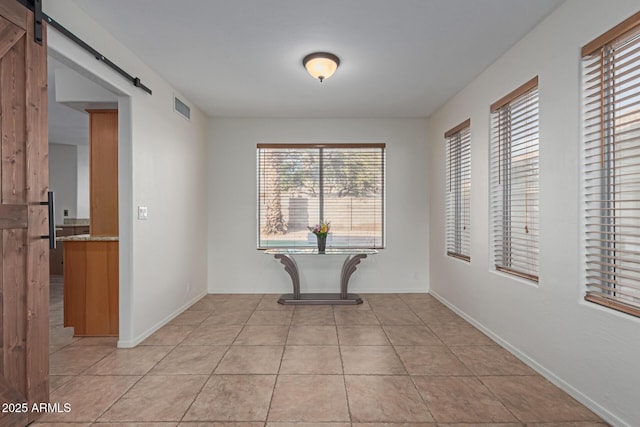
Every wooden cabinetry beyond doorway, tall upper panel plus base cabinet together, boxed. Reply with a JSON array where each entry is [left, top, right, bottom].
[[63, 110, 119, 336]]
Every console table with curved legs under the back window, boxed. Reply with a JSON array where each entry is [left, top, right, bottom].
[[265, 248, 378, 305]]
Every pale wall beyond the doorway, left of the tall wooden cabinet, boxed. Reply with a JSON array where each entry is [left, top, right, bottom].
[[49, 144, 78, 224]]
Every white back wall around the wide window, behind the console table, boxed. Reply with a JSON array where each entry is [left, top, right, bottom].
[[208, 119, 429, 293]]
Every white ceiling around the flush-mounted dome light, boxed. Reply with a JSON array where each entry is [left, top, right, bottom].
[[69, 0, 563, 117]]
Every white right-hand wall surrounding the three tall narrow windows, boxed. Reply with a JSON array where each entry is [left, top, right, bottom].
[[427, 0, 640, 426]]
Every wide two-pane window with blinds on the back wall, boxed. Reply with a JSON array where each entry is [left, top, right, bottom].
[[257, 144, 385, 248]]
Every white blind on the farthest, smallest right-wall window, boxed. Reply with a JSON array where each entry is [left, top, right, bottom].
[[444, 119, 471, 261]]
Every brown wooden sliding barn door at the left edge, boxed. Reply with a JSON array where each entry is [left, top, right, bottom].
[[0, 0, 49, 426]]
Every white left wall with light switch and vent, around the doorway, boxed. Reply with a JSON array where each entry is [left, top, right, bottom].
[[45, 0, 207, 347]]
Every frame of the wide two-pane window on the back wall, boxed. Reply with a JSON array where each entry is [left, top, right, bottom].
[[256, 143, 387, 250]]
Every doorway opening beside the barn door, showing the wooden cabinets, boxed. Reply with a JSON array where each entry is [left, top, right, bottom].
[[48, 55, 119, 358]]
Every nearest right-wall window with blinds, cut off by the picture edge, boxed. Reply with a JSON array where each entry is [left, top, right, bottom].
[[582, 13, 640, 316]]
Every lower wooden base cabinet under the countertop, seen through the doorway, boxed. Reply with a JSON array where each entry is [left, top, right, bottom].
[[64, 239, 119, 336]]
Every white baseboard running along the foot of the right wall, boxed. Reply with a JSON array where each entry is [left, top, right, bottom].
[[429, 290, 632, 427]]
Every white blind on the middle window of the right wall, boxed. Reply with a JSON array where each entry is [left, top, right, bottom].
[[490, 77, 540, 282]]
